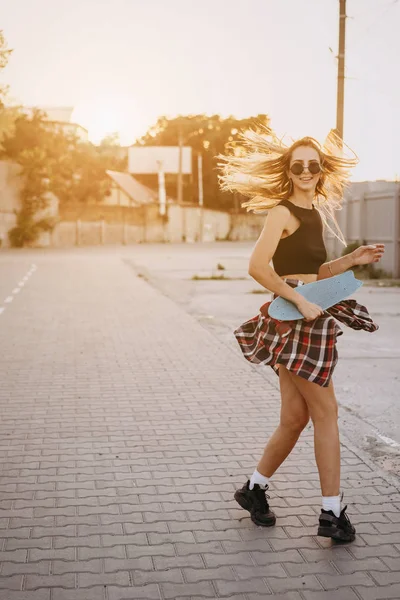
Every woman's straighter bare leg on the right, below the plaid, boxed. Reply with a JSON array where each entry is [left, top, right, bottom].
[[290, 373, 340, 496]]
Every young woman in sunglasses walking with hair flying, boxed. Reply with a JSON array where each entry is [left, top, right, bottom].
[[220, 131, 384, 541]]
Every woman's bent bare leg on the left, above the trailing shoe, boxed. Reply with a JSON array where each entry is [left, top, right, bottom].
[[257, 365, 310, 477]]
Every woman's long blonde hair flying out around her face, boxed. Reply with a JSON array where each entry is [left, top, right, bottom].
[[218, 126, 358, 245]]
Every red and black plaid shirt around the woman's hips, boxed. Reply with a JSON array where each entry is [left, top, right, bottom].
[[234, 279, 378, 387]]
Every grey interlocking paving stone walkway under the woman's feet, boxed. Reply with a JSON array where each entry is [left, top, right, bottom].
[[0, 251, 400, 600]]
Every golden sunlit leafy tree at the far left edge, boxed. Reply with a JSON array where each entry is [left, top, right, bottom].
[[0, 111, 125, 246]]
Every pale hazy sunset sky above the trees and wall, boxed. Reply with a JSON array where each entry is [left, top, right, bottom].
[[0, 0, 400, 180]]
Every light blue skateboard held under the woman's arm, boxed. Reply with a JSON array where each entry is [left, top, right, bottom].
[[268, 271, 362, 321]]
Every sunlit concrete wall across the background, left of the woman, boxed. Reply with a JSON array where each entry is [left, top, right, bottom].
[[0, 161, 265, 247]]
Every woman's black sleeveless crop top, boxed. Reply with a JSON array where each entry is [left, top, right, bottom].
[[272, 200, 327, 276]]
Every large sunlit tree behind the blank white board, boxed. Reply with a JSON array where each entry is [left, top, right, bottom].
[[135, 114, 269, 210]]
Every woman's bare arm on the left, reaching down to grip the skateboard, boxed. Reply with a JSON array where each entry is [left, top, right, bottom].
[[249, 205, 323, 320]]
